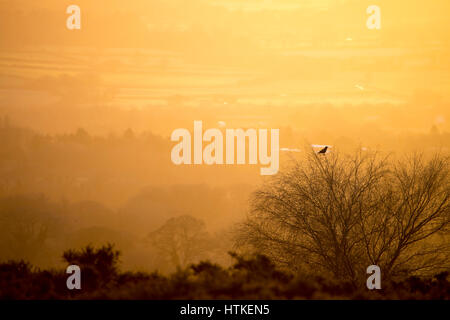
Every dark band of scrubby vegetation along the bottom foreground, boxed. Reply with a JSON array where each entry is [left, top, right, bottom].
[[0, 245, 450, 299]]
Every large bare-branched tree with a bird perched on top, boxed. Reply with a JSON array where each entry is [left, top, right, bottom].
[[237, 152, 450, 283]]
